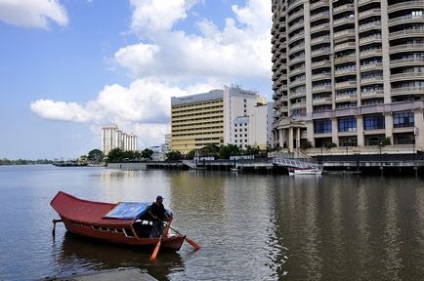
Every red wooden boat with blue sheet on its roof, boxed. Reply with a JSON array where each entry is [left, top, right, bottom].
[[50, 191, 186, 251]]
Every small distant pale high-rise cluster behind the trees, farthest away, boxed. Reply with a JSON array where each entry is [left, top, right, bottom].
[[102, 125, 137, 155]]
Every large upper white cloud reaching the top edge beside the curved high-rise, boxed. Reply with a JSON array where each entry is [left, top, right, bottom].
[[115, 0, 271, 83]]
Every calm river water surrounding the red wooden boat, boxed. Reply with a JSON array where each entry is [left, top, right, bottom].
[[0, 165, 424, 281]]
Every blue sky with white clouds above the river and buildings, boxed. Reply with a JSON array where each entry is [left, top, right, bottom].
[[0, 0, 272, 159]]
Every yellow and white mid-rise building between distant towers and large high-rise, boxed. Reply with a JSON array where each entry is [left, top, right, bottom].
[[171, 87, 272, 154]]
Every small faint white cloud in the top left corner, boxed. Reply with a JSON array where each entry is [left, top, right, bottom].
[[0, 0, 68, 28]]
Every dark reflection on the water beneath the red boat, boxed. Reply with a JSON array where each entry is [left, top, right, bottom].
[[58, 232, 184, 280]]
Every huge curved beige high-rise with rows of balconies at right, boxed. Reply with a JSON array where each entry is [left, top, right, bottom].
[[271, 0, 424, 152]]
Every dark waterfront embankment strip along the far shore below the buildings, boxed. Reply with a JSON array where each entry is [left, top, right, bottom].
[[107, 154, 424, 175]]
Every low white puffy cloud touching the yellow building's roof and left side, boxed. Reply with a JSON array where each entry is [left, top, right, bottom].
[[31, 78, 215, 147]]
